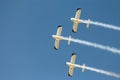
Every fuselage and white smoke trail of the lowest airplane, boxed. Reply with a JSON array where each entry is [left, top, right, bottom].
[[66, 62, 120, 78]]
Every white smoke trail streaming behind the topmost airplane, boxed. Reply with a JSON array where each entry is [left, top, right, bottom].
[[80, 20, 120, 31]]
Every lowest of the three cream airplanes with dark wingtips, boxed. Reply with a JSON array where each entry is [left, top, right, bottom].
[[66, 53, 85, 77]]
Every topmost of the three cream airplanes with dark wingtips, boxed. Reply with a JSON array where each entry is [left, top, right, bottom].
[[71, 8, 90, 33]]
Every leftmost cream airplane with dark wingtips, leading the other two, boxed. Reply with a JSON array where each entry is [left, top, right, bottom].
[[52, 25, 71, 50]]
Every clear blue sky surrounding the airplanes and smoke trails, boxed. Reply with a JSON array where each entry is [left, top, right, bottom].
[[0, 0, 120, 80]]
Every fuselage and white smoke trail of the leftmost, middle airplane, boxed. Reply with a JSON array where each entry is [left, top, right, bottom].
[[56, 36, 120, 54]]
